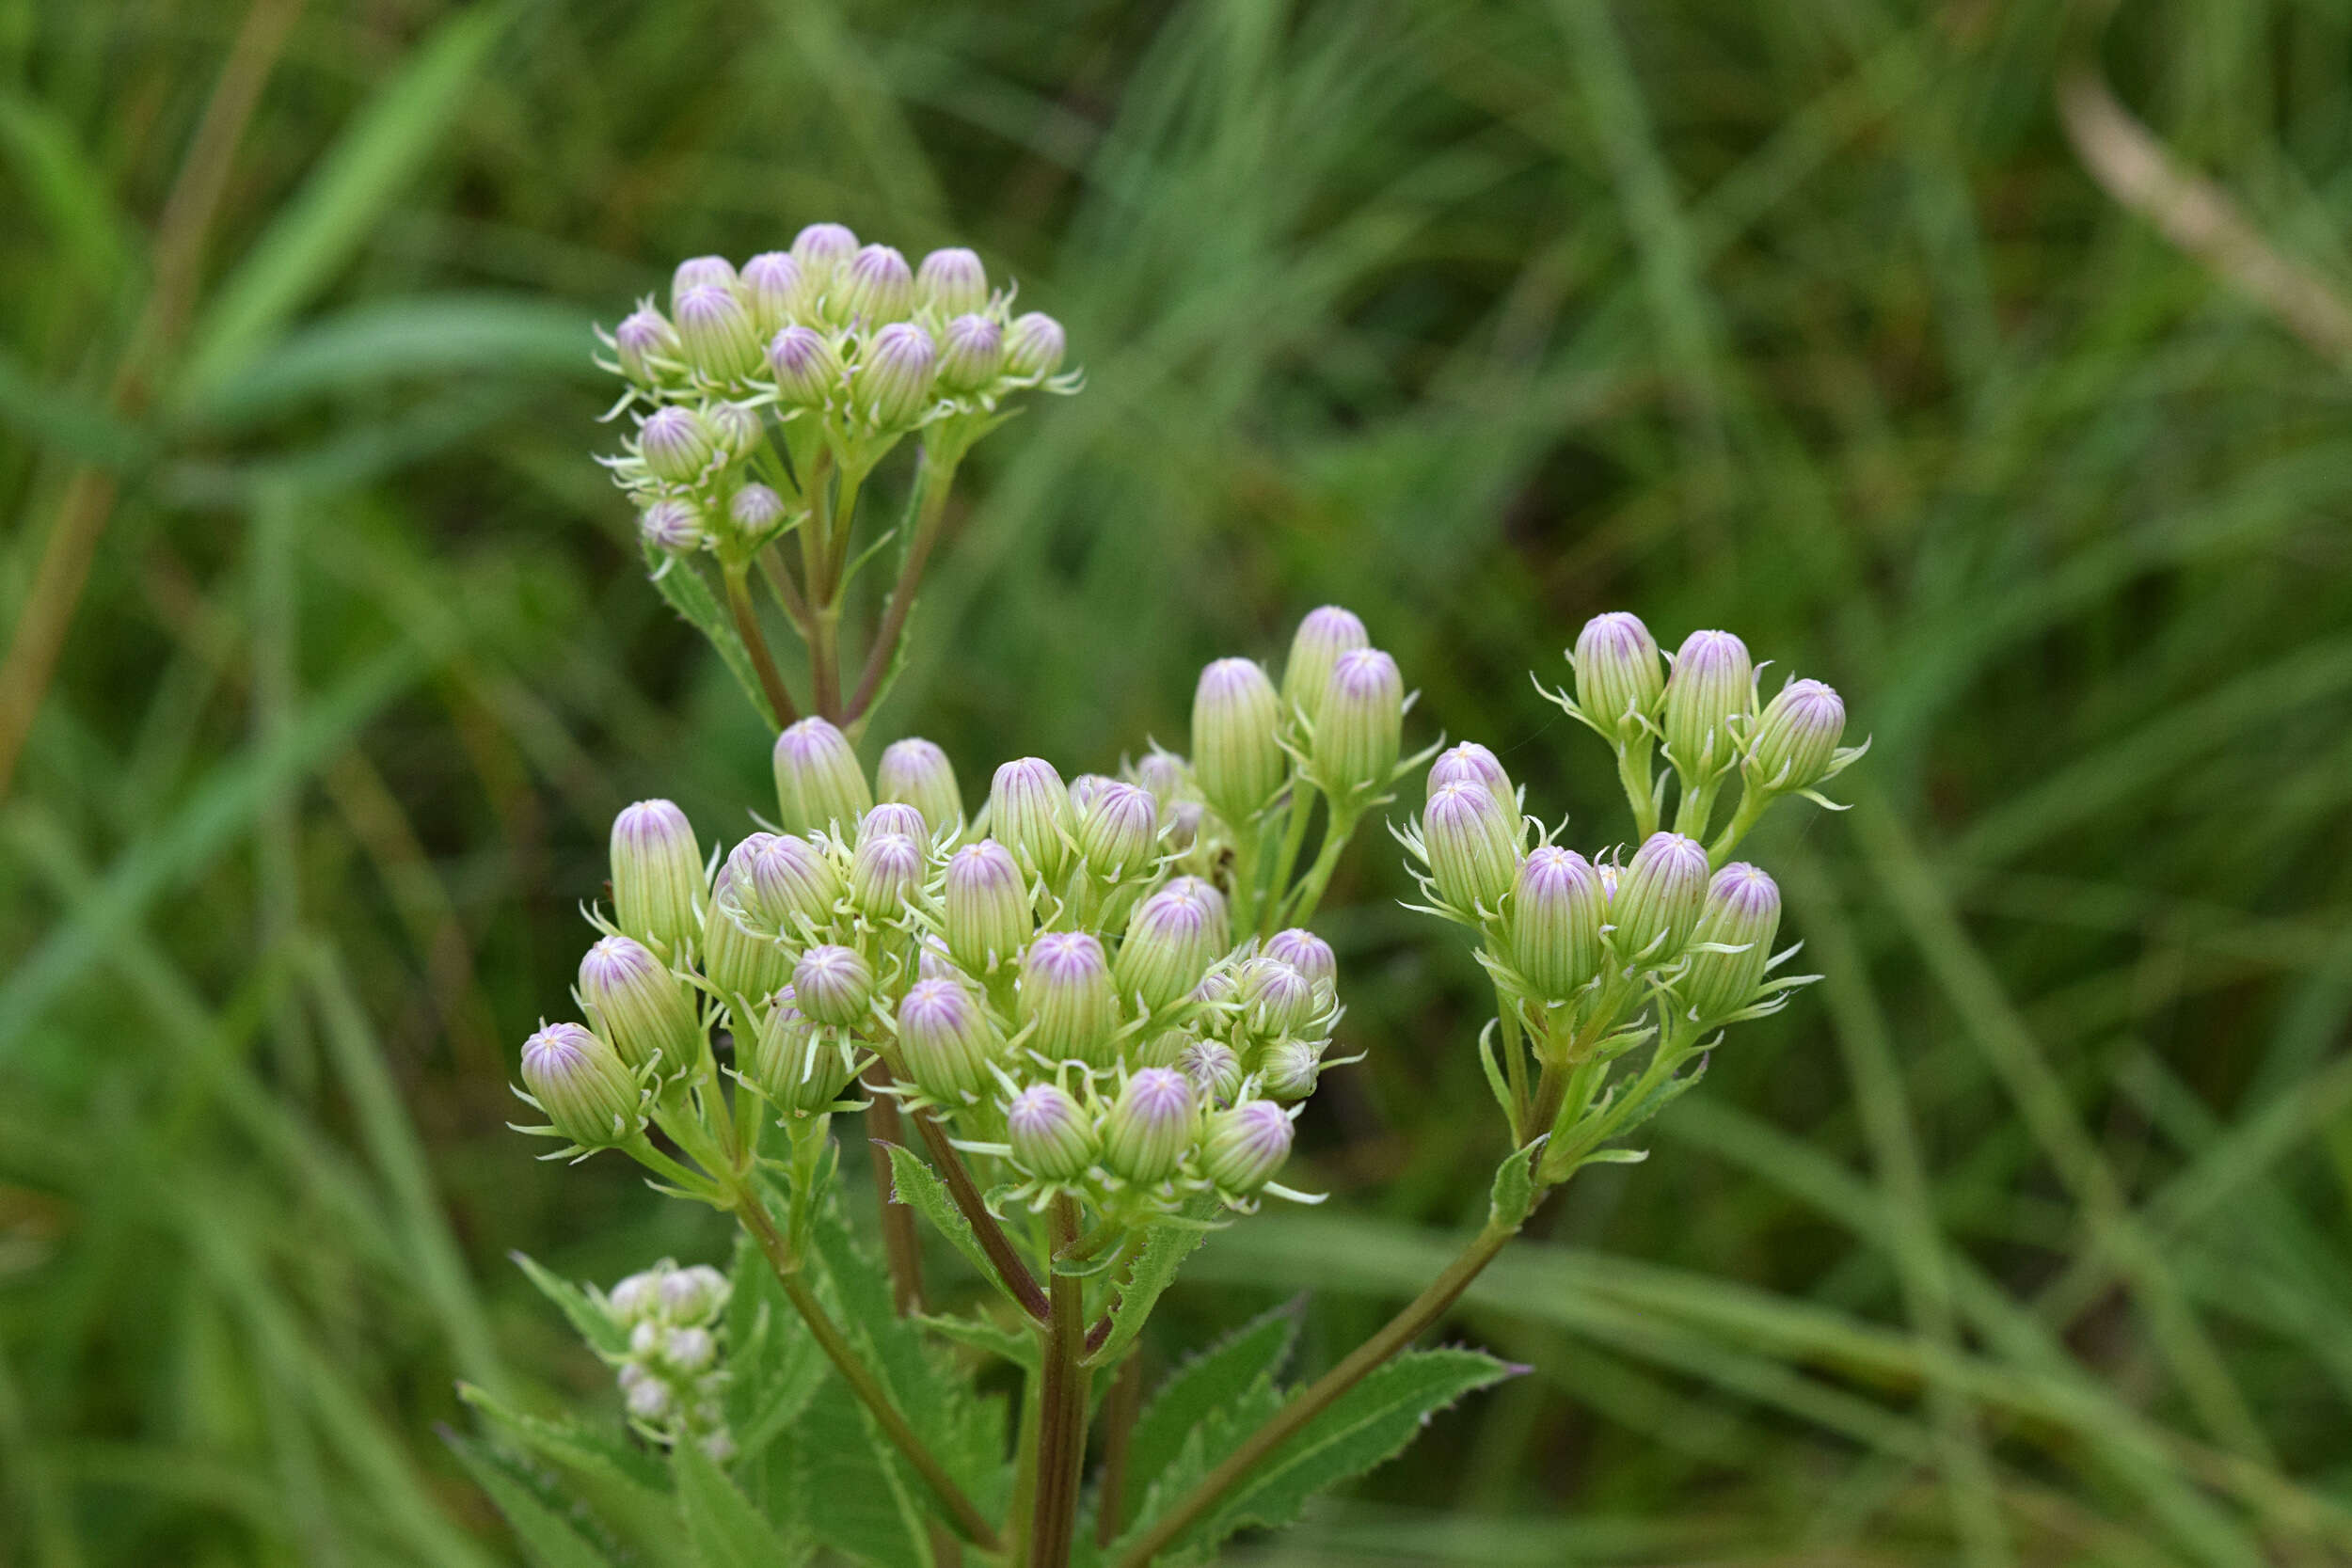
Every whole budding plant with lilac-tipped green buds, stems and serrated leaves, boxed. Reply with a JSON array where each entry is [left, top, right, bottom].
[[454, 223, 1858, 1568]]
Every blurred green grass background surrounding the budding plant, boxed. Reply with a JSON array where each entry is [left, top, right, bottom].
[[0, 0, 2352, 1566]]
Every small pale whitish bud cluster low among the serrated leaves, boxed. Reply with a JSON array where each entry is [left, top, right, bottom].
[[602, 1258, 737, 1465]]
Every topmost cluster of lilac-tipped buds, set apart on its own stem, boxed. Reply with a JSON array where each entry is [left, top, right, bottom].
[[602, 223, 1077, 566]]
